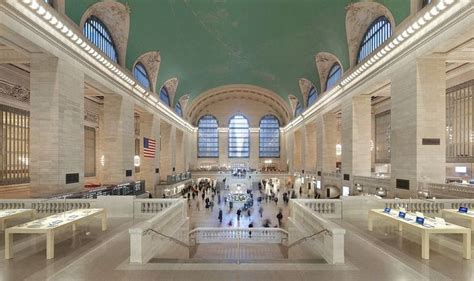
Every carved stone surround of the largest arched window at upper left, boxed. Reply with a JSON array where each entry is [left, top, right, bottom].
[[81, 1, 130, 66]]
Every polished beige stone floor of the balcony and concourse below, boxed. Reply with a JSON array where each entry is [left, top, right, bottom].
[[0, 182, 474, 281]]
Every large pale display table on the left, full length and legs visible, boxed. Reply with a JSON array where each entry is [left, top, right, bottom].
[[5, 209, 107, 259]]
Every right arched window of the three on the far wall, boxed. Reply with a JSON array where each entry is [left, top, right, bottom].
[[259, 115, 280, 158]]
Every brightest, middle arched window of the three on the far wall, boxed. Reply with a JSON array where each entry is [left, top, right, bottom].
[[229, 115, 250, 158]]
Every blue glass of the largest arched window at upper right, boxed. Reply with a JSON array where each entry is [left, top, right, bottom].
[[357, 16, 392, 63]]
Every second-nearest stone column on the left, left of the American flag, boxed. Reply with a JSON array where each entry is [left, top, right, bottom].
[[100, 95, 135, 183]]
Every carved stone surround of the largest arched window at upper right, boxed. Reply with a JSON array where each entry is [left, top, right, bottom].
[[346, 2, 395, 67]]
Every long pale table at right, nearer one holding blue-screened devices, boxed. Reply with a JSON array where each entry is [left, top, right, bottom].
[[368, 209, 471, 259]]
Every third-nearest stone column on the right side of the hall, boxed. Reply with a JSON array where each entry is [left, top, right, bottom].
[[316, 113, 337, 173]]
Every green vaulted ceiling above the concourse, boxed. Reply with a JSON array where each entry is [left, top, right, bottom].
[[66, 0, 410, 105]]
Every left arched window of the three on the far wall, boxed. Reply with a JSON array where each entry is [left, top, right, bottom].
[[198, 115, 219, 158]]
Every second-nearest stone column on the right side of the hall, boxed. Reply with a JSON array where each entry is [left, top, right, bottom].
[[341, 96, 372, 185]]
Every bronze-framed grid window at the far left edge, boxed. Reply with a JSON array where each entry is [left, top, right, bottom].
[[0, 105, 30, 185]]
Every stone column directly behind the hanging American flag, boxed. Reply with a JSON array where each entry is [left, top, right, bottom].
[[140, 113, 160, 192]]
